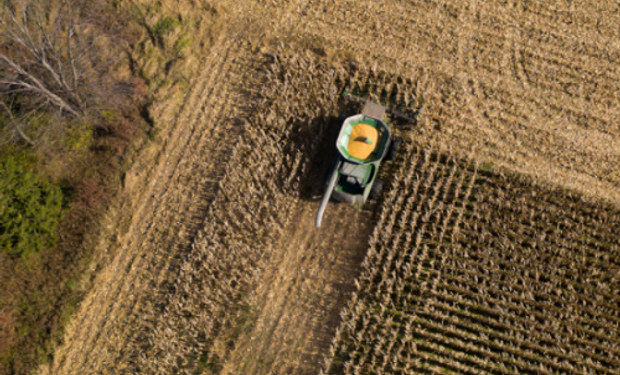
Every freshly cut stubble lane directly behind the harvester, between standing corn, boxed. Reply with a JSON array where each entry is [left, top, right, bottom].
[[220, 202, 372, 375]]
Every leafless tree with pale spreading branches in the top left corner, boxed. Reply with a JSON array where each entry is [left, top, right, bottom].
[[0, 0, 128, 148]]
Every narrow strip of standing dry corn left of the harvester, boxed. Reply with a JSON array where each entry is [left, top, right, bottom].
[[121, 50, 336, 374]]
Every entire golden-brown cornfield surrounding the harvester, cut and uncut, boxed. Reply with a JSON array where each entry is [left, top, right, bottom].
[[25, 0, 620, 375]]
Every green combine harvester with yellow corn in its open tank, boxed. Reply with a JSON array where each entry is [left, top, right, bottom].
[[315, 100, 402, 228]]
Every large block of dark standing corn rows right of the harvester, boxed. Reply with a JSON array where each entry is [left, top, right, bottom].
[[324, 150, 620, 374]]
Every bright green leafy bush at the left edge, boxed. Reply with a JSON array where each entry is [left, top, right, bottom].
[[0, 156, 62, 256]]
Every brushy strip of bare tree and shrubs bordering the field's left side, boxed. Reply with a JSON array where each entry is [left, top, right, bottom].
[[0, 0, 147, 374]]
